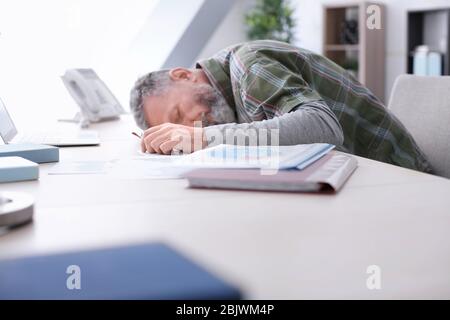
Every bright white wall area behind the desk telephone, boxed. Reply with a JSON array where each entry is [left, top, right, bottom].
[[0, 0, 203, 129]]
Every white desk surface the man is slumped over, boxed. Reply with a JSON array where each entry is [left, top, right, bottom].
[[0, 116, 450, 299]]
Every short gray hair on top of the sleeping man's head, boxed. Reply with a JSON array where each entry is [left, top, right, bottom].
[[130, 69, 172, 130]]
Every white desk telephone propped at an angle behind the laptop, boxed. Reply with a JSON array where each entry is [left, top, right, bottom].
[[61, 69, 125, 123]]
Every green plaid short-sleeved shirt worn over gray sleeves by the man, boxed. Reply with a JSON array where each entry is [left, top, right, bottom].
[[197, 40, 431, 172]]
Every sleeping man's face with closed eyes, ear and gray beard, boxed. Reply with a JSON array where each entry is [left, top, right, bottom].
[[143, 69, 235, 127]]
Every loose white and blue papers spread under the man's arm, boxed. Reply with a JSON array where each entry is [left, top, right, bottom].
[[49, 143, 340, 179]]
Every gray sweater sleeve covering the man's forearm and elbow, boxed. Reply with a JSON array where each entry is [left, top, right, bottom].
[[204, 101, 344, 147]]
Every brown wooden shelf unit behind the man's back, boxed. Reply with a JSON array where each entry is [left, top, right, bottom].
[[323, 1, 385, 101]]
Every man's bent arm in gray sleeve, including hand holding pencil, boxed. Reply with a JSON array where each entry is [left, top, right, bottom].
[[142, 101, 344, 154]]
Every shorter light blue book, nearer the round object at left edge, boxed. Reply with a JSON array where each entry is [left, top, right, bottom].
[[0, 157, 39, 182]]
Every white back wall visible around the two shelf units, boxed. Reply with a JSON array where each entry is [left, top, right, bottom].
[[292, 0, 450, 100]]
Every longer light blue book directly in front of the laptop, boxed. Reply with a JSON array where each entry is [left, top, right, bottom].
[[0, 143, 59, 163]]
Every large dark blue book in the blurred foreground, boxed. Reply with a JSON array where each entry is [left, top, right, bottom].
[[0, 243, 241, 300]]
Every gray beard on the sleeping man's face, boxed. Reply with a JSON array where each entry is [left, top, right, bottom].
[[195, 84, 236, 126]]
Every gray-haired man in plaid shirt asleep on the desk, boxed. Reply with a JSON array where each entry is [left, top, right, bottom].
[[130, 40, 432, 172]]
